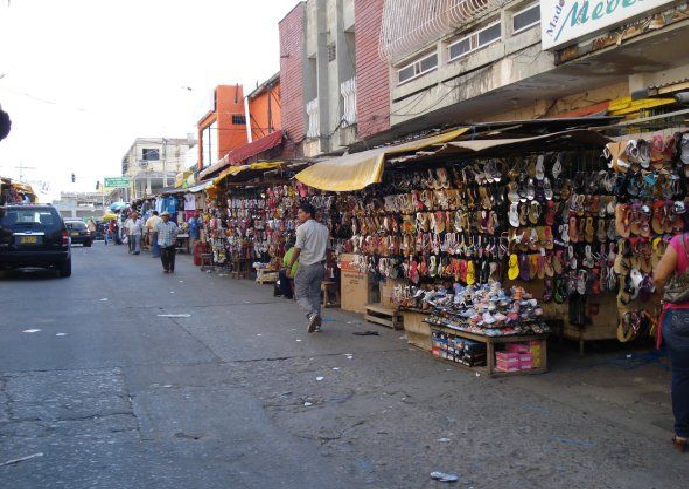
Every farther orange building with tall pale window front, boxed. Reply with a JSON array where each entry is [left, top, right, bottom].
[[197, 85, 247, 171]]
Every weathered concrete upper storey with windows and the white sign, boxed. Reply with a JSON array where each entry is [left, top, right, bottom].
[[379, 0, 689, 134]]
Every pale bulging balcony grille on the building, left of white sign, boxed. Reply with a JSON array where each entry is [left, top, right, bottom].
[[379, 0, 508, 64]]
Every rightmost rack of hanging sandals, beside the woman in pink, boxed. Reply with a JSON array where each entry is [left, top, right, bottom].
[[604, 133, 689, 342]]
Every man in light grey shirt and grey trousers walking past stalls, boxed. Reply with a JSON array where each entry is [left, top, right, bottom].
[[286, 202, 330, 333]]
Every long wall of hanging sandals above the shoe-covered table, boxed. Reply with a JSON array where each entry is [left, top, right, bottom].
[[336, 130, 689, 341]]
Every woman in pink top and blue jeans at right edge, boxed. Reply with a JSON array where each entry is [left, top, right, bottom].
[[654, 233, 689, 452]]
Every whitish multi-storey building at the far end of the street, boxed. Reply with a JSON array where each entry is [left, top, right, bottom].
[[122, 138, 196, 200]]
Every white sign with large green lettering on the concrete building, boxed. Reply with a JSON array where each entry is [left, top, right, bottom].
[[541, 0, 673, 50]]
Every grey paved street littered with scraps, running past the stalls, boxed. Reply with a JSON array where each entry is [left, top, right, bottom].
[[0, 244, 689, 489]]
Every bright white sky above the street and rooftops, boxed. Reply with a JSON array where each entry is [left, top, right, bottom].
[[0, 0, 298, 201]]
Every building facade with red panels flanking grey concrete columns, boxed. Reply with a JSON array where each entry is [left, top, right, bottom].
[[279, 0, 390, 158]]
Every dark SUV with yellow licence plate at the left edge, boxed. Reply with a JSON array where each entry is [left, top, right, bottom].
[[0, 204, 72, 277]]
